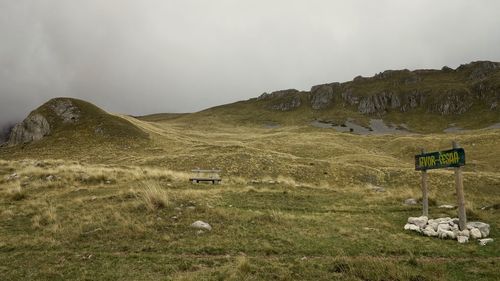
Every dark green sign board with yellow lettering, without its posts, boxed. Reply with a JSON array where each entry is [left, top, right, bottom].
[[415, 148, 465, 171]]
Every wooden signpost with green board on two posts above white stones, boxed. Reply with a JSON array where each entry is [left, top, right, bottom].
[[415, 141, 467, 230]]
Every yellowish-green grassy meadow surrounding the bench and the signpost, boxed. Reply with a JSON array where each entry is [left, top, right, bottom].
[[0, 113, 500, 280]]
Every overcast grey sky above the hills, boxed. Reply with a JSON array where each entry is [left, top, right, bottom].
[[0, 0, 500, 123]]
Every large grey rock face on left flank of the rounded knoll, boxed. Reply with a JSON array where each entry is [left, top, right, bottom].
[[8, 113, 50, 146]]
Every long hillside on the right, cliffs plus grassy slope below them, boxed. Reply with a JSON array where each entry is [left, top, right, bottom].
[[185, 61, 500, 133]]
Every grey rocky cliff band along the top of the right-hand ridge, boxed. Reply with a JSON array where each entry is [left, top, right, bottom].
[[257, 61, 500, 115]]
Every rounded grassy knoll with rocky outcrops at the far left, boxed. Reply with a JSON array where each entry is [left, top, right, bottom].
[[3, 98, 148, 155]]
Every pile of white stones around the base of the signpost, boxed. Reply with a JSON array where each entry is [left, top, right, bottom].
[[404, 216, 492, 244]]
